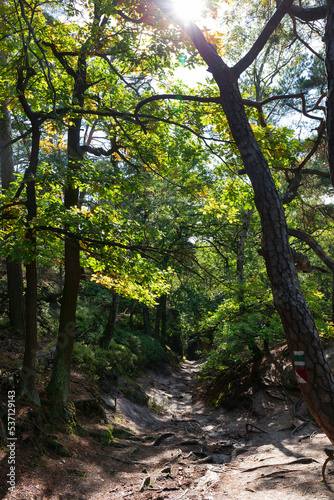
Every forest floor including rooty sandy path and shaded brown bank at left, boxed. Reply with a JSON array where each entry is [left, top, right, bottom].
[[0, 350, 334, 500]]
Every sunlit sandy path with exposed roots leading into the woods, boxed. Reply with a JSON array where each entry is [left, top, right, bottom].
[[100, 361, 334, 500]]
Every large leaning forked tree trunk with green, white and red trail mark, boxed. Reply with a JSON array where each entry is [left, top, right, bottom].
[[154, 0, 334, 442]]
